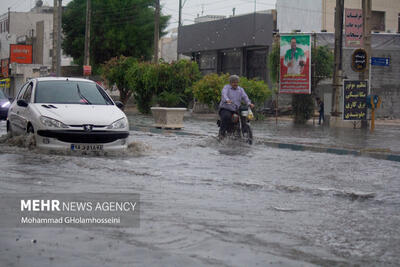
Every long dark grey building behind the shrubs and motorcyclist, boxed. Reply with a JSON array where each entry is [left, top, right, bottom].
[[178, 12, 274, 81]]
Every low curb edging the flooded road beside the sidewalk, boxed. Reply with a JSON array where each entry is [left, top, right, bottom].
[[130, 126, 400, 162]]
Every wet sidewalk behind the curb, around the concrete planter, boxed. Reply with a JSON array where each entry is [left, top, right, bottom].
[[128, 112, 400, 161]]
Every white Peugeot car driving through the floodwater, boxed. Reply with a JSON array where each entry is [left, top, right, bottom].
[[7, 77, 129, 151]]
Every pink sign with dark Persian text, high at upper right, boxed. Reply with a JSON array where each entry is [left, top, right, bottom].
[[345, 8, 363, 47]]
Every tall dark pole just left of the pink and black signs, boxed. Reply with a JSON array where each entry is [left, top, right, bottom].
[[331, 0, 344, 117]]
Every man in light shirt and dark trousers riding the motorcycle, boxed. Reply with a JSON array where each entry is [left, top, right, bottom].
[[219, 75, 254, 138]]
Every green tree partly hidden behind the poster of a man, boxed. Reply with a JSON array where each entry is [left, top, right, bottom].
[[268, 44, 333, 124]]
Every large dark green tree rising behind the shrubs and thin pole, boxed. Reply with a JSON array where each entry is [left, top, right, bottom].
[[62, 0, 170, 70]]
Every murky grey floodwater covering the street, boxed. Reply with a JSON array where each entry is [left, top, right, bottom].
[[0, 118, 400, 266]]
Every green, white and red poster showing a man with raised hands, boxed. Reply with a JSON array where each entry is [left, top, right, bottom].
[[279, 35, 311, 94]]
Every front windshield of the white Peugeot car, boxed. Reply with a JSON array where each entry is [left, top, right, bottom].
[[35, 80, 113, 105]]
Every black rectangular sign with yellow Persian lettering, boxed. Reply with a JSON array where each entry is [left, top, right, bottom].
[[343, 80, 368, 120]]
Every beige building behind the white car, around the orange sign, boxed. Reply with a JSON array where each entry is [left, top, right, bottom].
[[0, 6, 72, 97]]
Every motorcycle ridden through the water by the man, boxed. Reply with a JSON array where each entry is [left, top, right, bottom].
[[217, 106, 253, 145]]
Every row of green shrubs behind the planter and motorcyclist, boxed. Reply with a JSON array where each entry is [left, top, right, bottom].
[[102, 56, 272, 114]]
